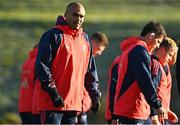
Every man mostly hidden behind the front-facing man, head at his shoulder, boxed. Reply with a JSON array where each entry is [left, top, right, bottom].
[[77, 32, 109, 124]]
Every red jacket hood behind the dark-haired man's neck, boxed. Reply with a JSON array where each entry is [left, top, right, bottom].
[[120, 37, 147, 51]]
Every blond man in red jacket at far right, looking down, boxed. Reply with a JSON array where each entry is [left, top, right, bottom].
[[151, 37, 178, 124]]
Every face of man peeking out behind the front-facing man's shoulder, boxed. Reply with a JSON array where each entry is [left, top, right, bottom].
[[92, 41, 106, 56]]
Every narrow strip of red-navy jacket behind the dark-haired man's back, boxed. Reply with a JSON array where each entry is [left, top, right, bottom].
[[105, 56, 121, 121]]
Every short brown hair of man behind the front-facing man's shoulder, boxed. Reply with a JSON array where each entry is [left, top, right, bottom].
[[90, 32, 109, 47]]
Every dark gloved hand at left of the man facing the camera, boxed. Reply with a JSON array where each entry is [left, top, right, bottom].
[[51, 95, 64, 108]]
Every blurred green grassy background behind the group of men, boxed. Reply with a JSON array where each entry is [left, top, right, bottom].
[[0, 0, 180, 124]]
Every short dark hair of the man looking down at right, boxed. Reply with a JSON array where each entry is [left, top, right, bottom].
[[140, 21, 166, 37]]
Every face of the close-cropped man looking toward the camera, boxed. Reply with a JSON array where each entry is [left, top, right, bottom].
[[65, 6, 85, 30]]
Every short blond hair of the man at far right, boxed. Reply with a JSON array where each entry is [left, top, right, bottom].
[[159, 37, 177, 51]]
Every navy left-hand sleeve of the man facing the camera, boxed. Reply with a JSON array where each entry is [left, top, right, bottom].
[[35, 29, 61, 90]]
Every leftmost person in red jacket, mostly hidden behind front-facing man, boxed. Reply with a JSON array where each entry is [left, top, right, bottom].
[[18, 45, 37, 124]]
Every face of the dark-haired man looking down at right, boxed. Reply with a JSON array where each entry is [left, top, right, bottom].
[[148, 36, 164, 53]]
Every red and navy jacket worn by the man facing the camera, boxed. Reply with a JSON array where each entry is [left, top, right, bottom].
[[36, 16, 99, 111]]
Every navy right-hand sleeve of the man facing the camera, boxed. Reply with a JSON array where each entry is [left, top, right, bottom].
[[85, 56, 101, 104]]
